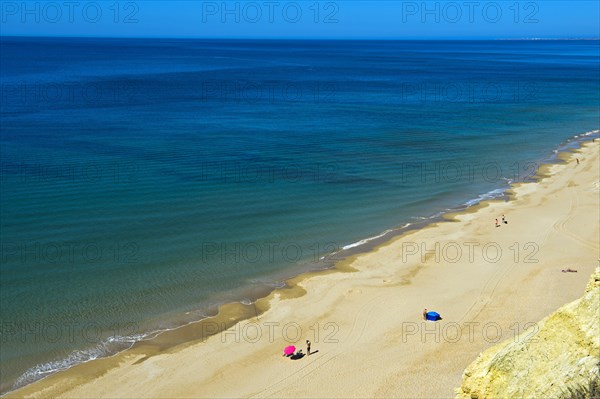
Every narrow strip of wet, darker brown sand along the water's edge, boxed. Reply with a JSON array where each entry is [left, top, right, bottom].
[[4, 131, 597, 397]]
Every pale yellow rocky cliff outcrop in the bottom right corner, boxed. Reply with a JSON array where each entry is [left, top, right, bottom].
[[457, 268, 600, 399]]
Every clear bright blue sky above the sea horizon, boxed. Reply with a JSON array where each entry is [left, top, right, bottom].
[[0, 0, 600, 39]]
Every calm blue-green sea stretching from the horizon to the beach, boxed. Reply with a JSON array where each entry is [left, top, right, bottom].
[[0, 37, 600, 392]]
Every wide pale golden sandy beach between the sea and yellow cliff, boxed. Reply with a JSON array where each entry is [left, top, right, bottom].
[[7, 140, 600, 398]]
